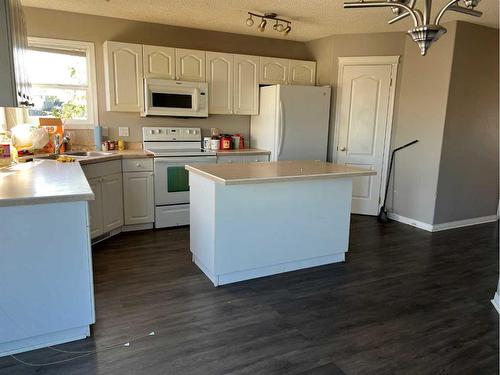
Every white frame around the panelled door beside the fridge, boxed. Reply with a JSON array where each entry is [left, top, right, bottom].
[[332, 55, 400, 209]]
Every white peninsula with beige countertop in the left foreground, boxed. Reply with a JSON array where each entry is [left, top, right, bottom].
[[0, 160, 95, 357]]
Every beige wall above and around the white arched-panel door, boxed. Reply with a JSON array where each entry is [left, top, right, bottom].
[[306, 33, 406, 160]]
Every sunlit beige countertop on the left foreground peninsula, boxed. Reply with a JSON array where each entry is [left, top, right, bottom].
[[0, 160, 94, 207]]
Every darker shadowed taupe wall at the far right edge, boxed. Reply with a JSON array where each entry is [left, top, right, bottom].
[[434, 22, 499, 224]]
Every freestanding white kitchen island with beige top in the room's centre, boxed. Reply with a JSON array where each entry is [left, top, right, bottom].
[[186, 161, 375, 286]]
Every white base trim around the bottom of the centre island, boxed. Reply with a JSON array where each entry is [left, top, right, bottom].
[[193, 253, 345, 286]]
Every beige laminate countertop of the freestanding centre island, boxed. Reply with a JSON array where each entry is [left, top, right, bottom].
[[186, 160, 376, 185]]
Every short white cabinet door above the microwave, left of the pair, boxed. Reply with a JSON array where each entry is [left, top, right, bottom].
[[142, 46, 175, 79]]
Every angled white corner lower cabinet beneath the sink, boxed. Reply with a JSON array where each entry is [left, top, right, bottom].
[[82, 160, 123, 238]]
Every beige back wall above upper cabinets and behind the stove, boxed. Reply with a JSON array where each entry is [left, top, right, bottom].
[[25, 8, 310, 142]]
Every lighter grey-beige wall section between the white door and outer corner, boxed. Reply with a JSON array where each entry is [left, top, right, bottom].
[[391, 23, 456, 224]]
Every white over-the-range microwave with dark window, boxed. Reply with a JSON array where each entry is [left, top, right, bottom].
[[142, 78, 208, 117]]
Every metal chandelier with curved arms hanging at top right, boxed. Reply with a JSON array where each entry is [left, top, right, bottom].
[[344, 0, 483, 56]]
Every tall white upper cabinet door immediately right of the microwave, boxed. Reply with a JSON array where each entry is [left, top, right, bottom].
[[206, 52, 234, 114]]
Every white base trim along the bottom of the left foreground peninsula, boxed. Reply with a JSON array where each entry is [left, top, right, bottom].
[[0, 325, 90, 357]]
